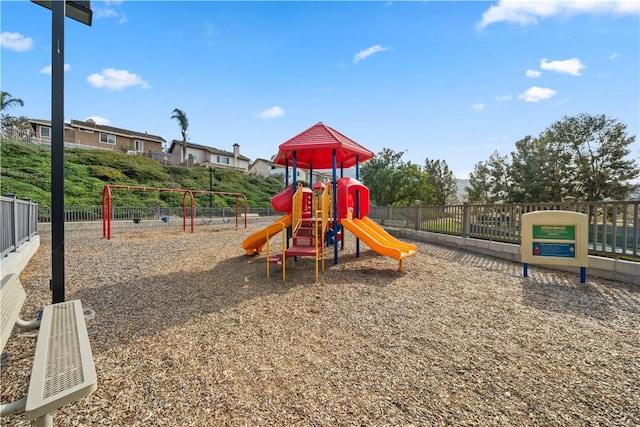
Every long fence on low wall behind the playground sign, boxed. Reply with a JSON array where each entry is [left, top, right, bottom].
[[370, 201, 640, 258]]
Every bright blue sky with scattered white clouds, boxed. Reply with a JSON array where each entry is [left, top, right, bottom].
[[0, 0, 640, 178]]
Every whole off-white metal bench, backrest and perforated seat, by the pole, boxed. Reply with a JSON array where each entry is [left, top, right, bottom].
[[0, 274, 98, 426]]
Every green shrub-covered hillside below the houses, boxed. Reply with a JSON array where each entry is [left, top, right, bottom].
[[0, 140, 283, 207]]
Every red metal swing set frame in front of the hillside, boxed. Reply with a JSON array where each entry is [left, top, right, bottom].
[[102, 184, 248, 240]]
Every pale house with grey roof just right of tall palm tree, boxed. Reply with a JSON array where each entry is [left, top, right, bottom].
[[167, 139, 250, 173]]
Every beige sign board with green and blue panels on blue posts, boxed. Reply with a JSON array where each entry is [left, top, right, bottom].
[[520, 211, 589, 283]]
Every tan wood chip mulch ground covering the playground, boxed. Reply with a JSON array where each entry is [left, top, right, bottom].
[[1, 224, 640, 426]]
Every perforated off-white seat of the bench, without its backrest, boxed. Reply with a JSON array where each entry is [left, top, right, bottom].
[[25, 300, 98, 419]]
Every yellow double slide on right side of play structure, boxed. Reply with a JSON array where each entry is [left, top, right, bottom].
[[341, 216, 418, 271]]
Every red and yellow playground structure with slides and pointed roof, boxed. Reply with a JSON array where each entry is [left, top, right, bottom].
[[242, 123, 417, 281]]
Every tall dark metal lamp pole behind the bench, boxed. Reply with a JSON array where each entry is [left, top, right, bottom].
[[50, 1, 66, 304]]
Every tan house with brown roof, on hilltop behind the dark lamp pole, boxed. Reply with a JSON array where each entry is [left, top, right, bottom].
[[29, 119, 166, 155]]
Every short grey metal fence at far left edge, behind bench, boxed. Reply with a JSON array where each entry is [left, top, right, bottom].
[[0, 194, 38, 258]]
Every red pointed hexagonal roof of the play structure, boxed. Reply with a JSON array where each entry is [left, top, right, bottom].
[[273, 122, 374, 169]]
